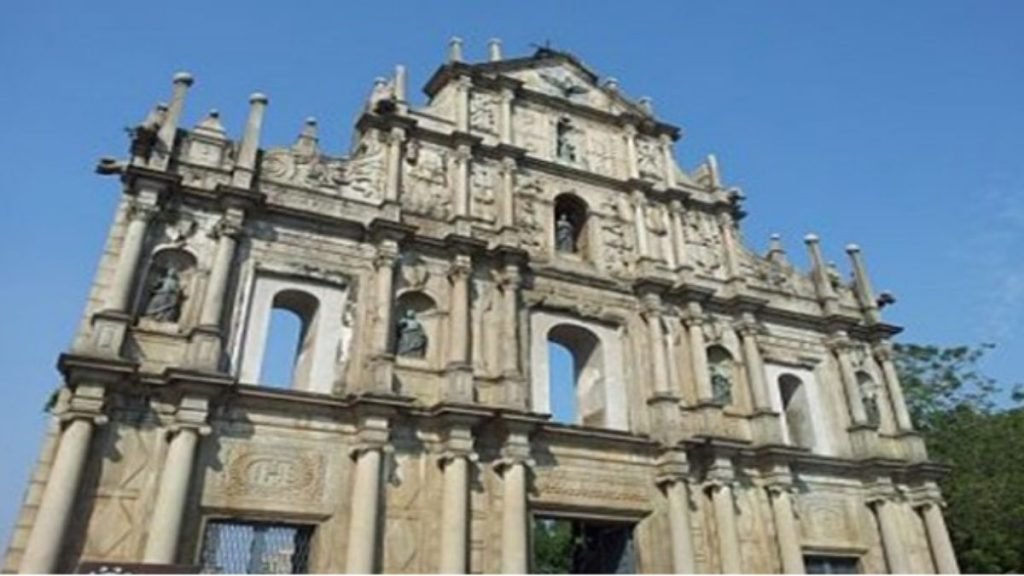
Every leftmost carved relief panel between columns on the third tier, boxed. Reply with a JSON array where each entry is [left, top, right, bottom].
[[401, 140, 452, 219]]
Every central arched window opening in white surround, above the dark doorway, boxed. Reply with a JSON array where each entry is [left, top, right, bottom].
[[548, 324, 606, 426]]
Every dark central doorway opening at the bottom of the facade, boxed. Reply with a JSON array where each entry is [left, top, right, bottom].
[[530, 516, 637, 574]]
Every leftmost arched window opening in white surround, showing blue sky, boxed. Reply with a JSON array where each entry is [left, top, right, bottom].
[[259, 290, 319, 388]]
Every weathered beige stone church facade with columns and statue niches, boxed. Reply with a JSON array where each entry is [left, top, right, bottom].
[[4, 41, 956, 573]]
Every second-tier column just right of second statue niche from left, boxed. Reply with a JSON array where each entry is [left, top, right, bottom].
[[445, 254, 473, 402]]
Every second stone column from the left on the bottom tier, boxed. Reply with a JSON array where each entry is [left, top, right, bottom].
[[142, 426, 200, 564]]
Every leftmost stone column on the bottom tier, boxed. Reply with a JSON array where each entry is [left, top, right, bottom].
[[18, 414, 104, 574]]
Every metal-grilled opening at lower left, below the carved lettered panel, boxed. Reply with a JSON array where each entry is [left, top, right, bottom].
[[200, 520, 313, 574]]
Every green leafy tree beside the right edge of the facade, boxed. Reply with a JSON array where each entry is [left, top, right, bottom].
[[895, 344, 1024, 573]]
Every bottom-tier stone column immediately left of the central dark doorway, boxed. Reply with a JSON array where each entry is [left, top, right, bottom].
[[497, 430, 534, 574]]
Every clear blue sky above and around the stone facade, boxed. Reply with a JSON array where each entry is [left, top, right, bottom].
[[0, 0, 1024, 546]]
